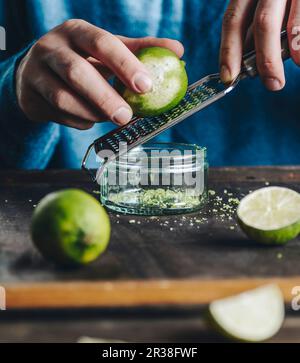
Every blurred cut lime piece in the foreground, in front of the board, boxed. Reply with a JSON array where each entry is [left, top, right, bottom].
[[209, 285, 285, 342]]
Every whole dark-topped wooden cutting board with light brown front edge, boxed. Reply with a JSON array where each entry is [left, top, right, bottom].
[[0, 167, 300, 309]]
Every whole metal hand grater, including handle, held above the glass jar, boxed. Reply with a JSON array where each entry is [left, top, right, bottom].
[[82, 30, 290, 181]]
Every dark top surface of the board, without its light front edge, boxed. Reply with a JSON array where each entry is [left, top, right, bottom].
[[0, 168, 300, 284]]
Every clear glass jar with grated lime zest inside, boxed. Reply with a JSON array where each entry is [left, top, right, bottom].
[[100, 143, 208, 216]]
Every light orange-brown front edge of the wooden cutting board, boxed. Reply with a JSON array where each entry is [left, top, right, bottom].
[[6, 276, 300, 309]]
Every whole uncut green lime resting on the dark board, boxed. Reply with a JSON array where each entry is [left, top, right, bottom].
[[31, 189, 110, 265]]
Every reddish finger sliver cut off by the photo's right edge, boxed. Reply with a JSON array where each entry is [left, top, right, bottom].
[[287, 0, 300, 66]]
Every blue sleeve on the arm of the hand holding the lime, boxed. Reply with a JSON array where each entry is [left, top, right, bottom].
[[0, 47, 60, 169]]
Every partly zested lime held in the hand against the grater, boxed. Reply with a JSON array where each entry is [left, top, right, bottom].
[[116, 47, 188, 117]]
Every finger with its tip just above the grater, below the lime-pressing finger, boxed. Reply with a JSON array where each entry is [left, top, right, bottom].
[[44, 47, 132, 125]]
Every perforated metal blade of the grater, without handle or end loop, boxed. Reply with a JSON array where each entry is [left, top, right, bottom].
[[94, 74, 237, 158]]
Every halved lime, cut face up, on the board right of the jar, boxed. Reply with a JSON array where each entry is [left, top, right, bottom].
[[237, 187, 300, 244]]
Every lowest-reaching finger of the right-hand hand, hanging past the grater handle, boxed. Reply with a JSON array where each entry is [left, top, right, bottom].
[[254, 0, 287, 91]]
